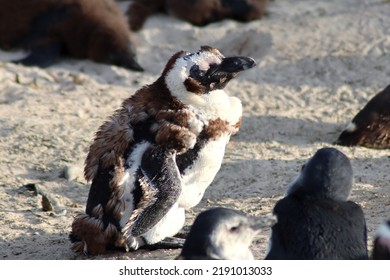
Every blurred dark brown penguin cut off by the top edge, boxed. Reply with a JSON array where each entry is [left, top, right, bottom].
[[126, 0, 268, 31]]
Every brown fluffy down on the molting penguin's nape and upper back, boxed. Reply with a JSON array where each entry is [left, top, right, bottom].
[[84, 52, 191, 181]]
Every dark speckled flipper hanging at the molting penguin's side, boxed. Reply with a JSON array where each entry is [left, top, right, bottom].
[[124, 147, 181, 236]]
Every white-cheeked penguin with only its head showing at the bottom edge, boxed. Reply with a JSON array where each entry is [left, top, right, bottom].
[[176, 207, 273, 260]]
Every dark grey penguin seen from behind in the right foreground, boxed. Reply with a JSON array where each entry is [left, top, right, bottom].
[[266, 148, 368, 260]]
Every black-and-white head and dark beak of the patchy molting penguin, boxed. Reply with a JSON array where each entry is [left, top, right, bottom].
[[162, 46, 256, 99]]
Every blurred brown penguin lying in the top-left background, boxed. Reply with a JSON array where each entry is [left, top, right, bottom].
[[0, 0, 143, 71]]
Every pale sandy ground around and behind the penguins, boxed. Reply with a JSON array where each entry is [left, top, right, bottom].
[[0, 0, 390, 259]]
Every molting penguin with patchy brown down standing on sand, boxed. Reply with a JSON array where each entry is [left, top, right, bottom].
[[70, 46, 256, 254]]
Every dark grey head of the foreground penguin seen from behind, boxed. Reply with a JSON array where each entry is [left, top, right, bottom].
[[287, 148, 353, 201]]
